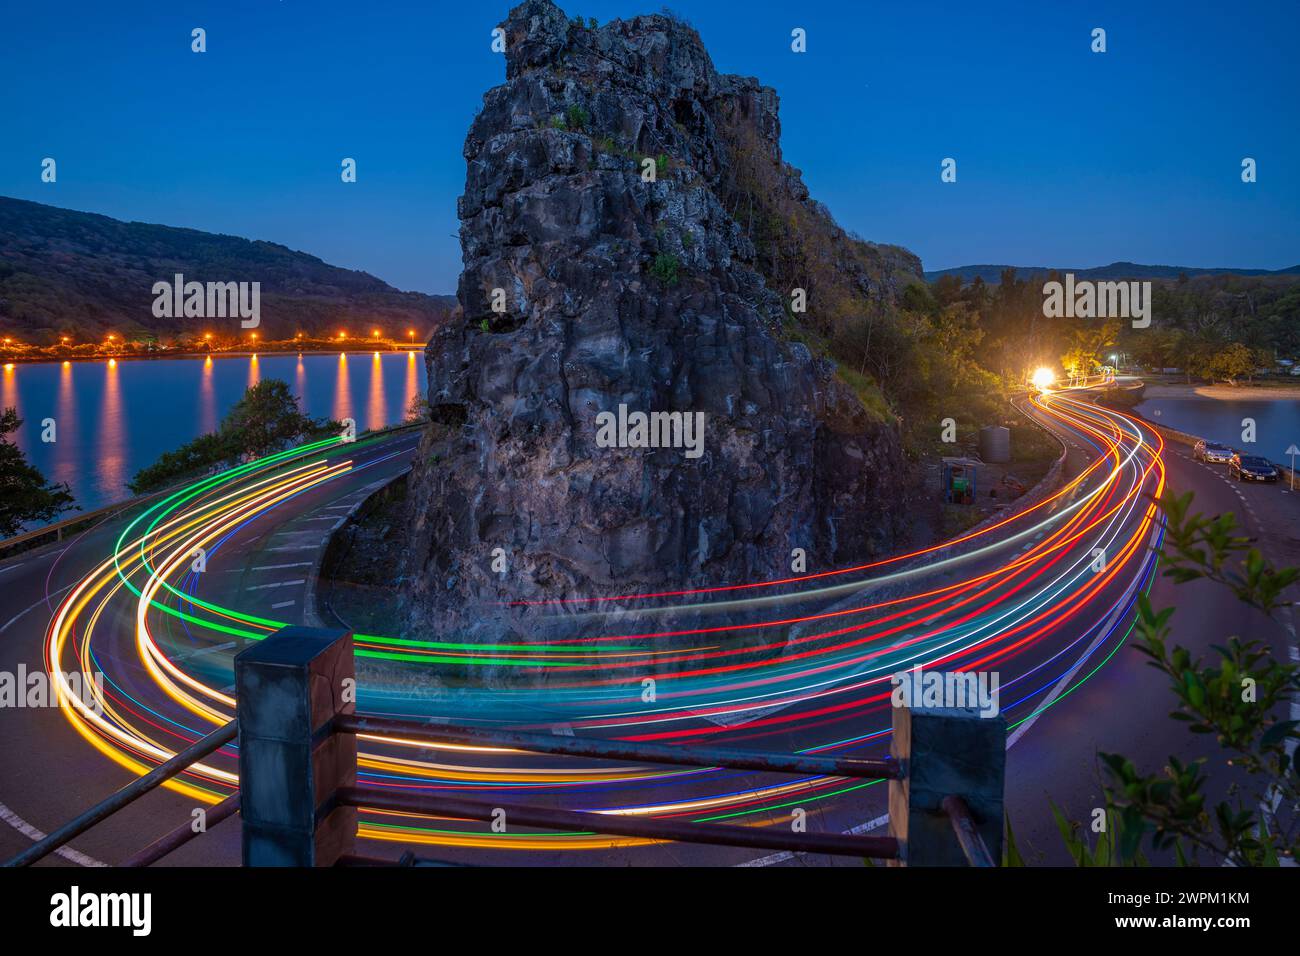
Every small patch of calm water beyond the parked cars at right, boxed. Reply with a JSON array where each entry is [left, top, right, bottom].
[[1138, 398, 1300, 463]]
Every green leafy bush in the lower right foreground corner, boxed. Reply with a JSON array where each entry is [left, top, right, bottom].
[[1053, 490, 1300, 866]]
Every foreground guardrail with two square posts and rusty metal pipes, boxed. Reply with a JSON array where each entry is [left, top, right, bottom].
[[7, 627, 1006, 866]]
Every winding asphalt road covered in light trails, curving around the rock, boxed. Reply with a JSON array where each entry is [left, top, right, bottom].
[[0, 392, 1300, 866]]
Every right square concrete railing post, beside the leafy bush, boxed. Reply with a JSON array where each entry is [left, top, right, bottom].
[[889, 706, 1006, 866]]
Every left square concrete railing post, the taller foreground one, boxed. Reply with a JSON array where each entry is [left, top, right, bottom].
[[235, 627, 356, 866]]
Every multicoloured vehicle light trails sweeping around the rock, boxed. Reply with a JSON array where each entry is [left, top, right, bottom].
[[46, 394, 1165, 851]]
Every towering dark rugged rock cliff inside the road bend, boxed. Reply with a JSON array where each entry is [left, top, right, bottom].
[[404, 0, 920, 639]]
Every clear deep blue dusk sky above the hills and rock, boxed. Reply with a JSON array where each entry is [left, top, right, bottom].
[[0, 0, 1300, 293]]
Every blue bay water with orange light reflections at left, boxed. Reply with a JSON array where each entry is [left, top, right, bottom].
[[0, 351, 425, 511]]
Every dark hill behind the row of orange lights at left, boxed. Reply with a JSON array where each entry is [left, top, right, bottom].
[[0, 196, 456, 343]]
